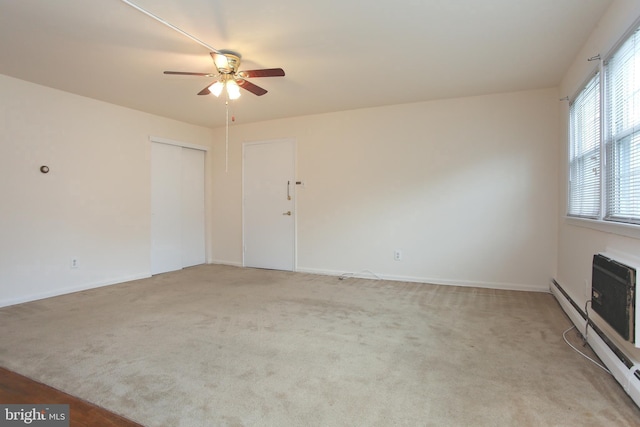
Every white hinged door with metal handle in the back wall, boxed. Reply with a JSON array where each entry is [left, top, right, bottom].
[[243, 140, 295, 271]]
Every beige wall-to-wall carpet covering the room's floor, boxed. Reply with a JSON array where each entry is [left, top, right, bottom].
[[0, 265, 640, 427]]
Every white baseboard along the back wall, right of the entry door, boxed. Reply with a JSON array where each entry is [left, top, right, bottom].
[[296, 267, 549, 293]]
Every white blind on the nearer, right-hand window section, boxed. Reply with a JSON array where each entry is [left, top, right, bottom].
[[604, 30, 640, 223]]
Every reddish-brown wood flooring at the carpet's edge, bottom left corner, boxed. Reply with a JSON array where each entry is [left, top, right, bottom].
[[0, 368, 142, 427]]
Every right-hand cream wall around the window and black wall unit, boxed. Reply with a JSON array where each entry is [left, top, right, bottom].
[[557, 0, 640, 360]]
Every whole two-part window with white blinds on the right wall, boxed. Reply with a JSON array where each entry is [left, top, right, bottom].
[[567, 25, 640, 224]]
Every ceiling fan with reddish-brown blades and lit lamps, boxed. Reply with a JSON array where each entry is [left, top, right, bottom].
[[164, 50, 284, 99]]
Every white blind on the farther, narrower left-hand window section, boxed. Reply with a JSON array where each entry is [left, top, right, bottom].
[[567, 74, 601, 218]]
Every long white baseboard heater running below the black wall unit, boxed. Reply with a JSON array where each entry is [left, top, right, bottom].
[[550, 279, 640, 407]]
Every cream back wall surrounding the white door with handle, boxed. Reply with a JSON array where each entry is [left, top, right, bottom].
[[211, 89, 559, 290]]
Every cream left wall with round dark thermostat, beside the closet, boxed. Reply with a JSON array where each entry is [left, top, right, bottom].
[[0, 75, 213, 306]]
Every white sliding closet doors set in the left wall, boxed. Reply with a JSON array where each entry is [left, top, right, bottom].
[[151, 143, 205, 274]]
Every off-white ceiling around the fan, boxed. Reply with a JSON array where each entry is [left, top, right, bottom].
[[0, 0, 611, 127]]
